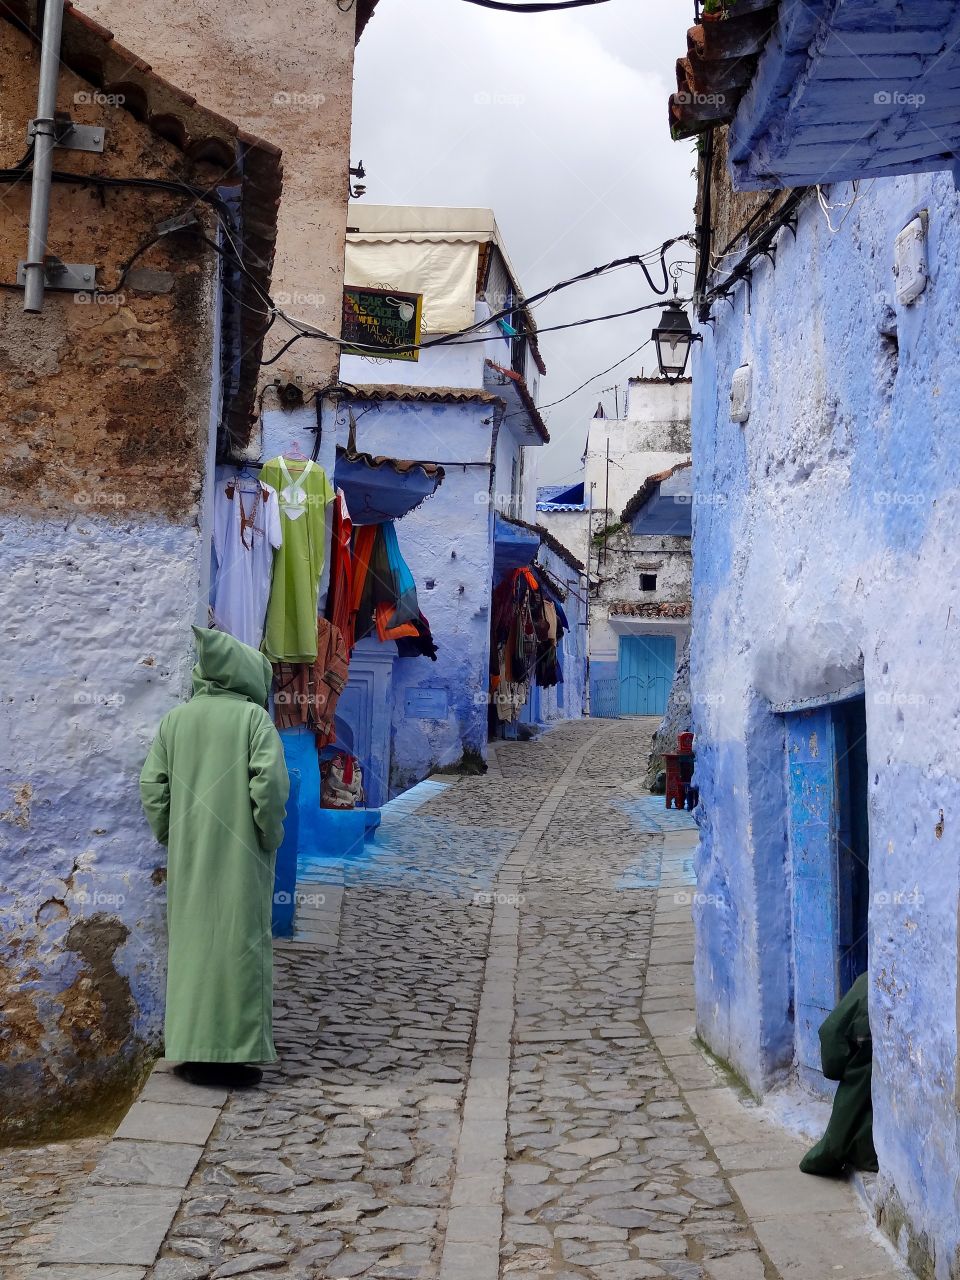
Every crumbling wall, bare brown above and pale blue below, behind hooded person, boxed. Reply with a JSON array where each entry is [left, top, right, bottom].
[[0, 23, 216, 1139]]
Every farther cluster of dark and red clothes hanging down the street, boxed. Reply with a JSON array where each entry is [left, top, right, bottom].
[[490, 564, 570, 723]]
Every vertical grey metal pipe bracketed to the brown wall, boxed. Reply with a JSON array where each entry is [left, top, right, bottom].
[[23, 0, 63, 311]]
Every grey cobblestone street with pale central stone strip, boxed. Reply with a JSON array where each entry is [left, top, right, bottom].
[[4, 721, 900, 1280]]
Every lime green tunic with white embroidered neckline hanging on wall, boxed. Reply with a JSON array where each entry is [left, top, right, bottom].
[[260, 457, 334, 663]]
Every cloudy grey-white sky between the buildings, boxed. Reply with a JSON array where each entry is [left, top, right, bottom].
[[353, 0, 695, 483]]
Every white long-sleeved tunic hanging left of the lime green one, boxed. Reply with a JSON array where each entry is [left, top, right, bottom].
[[210, 475, 283, 649]]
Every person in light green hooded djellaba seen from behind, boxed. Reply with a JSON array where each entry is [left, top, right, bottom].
[[140, 627, 289, 1085]]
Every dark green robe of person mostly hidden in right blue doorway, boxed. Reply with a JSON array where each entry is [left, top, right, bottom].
[[800, 973, 877, 1178]]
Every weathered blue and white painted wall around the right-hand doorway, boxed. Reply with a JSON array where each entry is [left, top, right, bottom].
[[691, 167, 960, 1280]]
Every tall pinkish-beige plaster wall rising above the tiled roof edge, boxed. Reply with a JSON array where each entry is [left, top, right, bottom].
[[84, 0, 357, 388]]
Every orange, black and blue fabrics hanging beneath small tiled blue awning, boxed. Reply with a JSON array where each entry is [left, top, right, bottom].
[[353, 521, 436, 662]]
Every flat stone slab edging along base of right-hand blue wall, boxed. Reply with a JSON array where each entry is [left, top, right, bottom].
[[641, 832, 915, 1280]]
